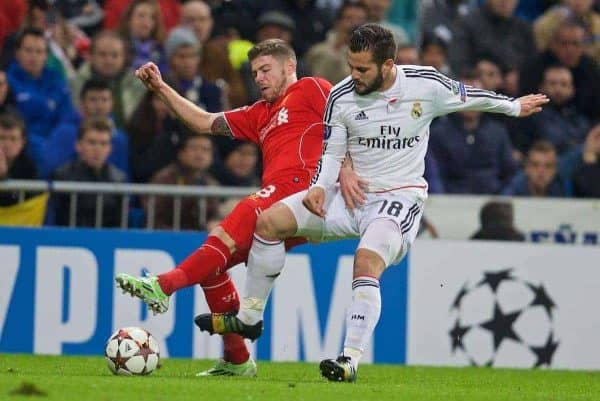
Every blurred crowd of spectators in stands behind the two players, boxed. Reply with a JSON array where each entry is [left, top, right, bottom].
[[0, 0, 600, 229]]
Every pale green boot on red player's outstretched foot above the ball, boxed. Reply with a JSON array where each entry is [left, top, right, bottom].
[[115, 273, 169, 314]]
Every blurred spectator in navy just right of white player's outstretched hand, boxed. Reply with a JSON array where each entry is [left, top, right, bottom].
[[528, 65, 590, 155]]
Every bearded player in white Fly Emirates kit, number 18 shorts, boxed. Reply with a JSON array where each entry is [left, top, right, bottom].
[[196, 24, 548, 381]]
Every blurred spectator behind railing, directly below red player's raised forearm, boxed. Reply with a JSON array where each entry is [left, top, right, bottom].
[[145, 133, 218, 231]]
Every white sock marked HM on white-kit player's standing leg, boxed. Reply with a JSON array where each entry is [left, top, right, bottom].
[[344, 276, 381, 367]]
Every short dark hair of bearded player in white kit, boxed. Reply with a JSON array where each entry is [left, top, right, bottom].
[[349, 24, 396, 66]]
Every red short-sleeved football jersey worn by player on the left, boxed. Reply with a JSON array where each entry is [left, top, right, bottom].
[[224, 77, 331, 184]]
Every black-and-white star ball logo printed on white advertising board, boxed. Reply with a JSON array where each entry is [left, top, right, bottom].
[[448, 269, 560, 367]]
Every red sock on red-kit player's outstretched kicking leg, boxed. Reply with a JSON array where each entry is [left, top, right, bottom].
[[158, 235, 231, 295]]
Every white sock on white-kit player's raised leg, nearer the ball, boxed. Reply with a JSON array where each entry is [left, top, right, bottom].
[[237, 234, 285, 325]]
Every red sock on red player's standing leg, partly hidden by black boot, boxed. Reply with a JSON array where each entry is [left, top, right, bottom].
[[201, 273, 250, 364]]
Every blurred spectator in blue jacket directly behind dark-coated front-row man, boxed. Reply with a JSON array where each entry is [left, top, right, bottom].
[[40, 79, 129, 177]]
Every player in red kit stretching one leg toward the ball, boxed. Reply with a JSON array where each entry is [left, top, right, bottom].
[[116, 39, 331, 376]]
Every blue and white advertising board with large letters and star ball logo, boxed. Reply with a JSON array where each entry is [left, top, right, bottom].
[[0, 228, 600, 369]]
